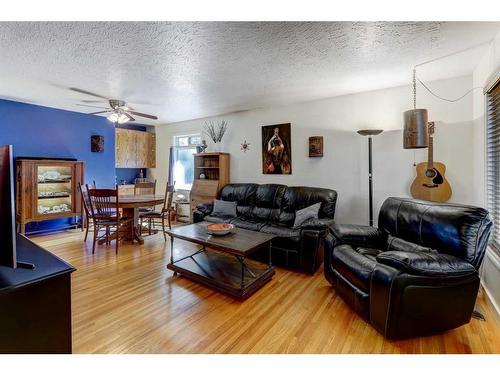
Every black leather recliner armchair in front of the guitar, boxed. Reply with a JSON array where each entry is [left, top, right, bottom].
[[324, 198, 492, 339]]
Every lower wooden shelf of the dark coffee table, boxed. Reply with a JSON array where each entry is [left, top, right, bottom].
[[167, 250, 275, 299]]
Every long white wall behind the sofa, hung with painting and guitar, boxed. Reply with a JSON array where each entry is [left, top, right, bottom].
[[152, 76, 474, 224]]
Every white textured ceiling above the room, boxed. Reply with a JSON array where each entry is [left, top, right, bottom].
[[0, 22, 500, 125]]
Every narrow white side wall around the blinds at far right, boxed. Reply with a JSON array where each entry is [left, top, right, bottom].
[[473, 34, 500, 314]]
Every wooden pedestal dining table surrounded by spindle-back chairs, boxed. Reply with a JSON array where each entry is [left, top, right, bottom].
[[99, 194, 165, 244]]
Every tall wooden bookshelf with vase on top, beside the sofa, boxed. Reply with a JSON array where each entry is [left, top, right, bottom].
[[191, 152, 229, 222]]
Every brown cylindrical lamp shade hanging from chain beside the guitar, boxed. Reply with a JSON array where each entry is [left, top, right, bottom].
[[403, 109, 429, 149]]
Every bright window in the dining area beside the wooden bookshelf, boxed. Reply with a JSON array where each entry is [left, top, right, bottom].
[[174, 134, 201, 190]]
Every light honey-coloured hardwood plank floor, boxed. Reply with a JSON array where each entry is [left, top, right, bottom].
[[32, 231, 500, 353]]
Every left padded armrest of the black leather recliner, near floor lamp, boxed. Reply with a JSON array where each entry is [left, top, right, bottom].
[[330, 223, 387, 248]]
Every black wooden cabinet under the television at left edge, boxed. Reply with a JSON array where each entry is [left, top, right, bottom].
[[0, 235, 75, 353]]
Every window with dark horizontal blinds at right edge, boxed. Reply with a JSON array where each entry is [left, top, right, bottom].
[[486, 81, 500, 254]]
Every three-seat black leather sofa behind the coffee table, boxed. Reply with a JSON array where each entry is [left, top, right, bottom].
[[193, 183, 337, 274]]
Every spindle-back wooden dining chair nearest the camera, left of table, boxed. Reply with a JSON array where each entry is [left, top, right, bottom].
[[87, 185, 133, 254]]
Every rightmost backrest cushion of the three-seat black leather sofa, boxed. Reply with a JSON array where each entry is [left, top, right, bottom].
[[279, 186, 337, 227]]
